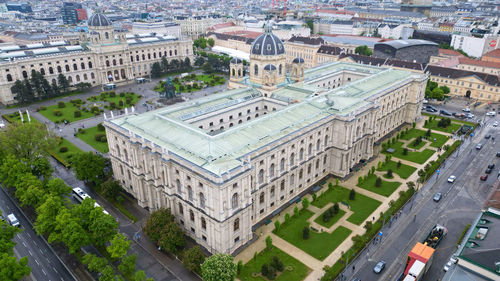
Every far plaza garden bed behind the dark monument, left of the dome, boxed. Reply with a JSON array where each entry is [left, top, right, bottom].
[[154, 73, 226, 93]]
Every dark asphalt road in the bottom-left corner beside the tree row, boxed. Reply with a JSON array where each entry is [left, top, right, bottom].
[[0, 188, 75, 281]]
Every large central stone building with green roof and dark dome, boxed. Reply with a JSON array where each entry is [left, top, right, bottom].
[[104, 24, 427, 253]]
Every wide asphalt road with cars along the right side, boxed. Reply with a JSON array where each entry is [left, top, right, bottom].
[[345, 112, 500, 281]]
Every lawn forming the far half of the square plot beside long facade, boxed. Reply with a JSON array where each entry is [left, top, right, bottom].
[[311, 186, 381, 225]]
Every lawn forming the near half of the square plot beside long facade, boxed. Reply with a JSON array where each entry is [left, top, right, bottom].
[[274, 210, 352, 260]]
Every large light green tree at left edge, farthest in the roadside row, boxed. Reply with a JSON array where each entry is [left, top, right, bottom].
[[0, 122, 56, 164]]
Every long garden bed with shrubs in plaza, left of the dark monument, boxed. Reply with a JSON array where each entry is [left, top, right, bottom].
[[38, 91, 142, 124]]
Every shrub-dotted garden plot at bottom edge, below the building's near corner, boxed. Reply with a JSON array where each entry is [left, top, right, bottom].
[[237, 241, 310, 281]]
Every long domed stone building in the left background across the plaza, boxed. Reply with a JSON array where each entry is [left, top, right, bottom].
[[0, 14, 193, 104]]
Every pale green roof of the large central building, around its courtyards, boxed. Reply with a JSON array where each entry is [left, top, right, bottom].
[[108, 62, 415, 176]]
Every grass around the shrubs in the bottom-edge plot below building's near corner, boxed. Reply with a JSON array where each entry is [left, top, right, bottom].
[[238, 246, 310, 281]]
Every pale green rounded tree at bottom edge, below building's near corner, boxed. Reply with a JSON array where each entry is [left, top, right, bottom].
[[201, 253, 236, 281]]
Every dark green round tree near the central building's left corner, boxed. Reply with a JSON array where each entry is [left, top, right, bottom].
[[72, 152, 107, 186]]
